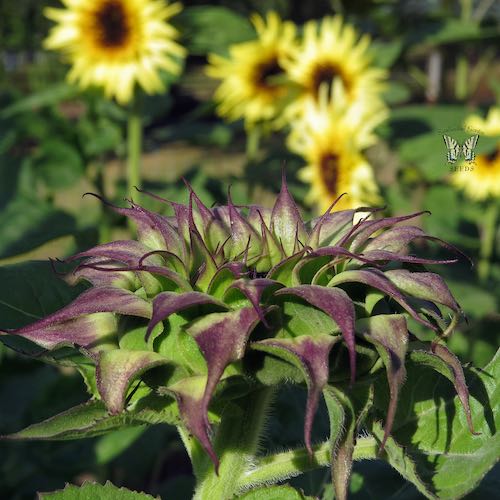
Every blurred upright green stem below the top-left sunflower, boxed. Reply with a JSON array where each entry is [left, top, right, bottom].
[[127, 98, 142, 199]]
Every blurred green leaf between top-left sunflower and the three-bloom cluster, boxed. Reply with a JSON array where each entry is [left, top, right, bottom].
[[176, 5, 255, 55]]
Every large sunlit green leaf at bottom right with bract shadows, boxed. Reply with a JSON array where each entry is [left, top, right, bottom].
[[376, 351, 500, 499]]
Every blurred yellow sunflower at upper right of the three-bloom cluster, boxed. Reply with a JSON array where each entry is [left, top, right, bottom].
[[286, 16, 387, 117]]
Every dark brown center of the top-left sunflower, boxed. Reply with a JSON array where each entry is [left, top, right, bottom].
[[95, 0, 130, 48]]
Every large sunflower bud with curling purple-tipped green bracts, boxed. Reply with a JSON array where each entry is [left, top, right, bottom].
[[3, 176, 474, 498]]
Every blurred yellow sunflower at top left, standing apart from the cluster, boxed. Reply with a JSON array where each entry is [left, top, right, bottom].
[[44, 0, 185, 104]]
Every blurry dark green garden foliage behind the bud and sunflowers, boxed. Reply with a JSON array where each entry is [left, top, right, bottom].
[[0, 0, 500, 499]]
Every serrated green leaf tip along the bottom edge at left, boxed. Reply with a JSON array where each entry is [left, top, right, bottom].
[[38, 481, 160, 500]]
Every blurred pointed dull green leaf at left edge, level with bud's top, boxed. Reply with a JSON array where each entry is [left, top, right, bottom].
[[0, 196, 75, 258]]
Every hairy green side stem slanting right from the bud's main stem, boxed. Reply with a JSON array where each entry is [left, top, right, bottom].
[[238, 437, 379, 491]]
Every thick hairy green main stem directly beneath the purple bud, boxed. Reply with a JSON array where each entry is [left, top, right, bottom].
[[194, 387, 274, 500]]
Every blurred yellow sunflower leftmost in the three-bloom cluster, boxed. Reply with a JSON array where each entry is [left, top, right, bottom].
[[207, 12, 296, 127]]
